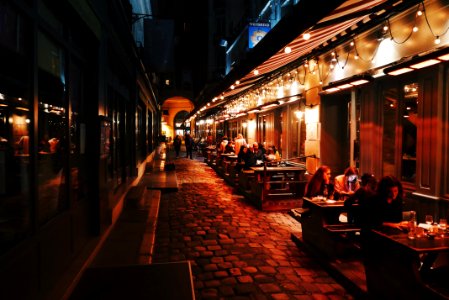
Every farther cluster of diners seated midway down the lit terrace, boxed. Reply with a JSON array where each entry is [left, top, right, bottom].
[[217, 134, 281, 172]]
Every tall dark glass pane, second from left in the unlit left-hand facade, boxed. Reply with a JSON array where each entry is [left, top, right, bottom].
[[37, 34, 68, 224]]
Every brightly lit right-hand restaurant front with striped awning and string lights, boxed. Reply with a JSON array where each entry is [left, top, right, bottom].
[[189, 0, 449, 220]]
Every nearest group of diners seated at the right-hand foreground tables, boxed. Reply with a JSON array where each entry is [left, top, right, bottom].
[[304, 165, 407, 229]]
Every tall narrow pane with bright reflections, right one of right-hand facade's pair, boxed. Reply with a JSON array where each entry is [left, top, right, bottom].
[[401, 83, 418, 183]]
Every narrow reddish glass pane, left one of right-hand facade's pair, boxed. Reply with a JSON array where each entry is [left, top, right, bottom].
[[382, 88, 398, 175]]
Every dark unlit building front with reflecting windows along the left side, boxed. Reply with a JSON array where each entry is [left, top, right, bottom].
[[0, 0, 160, 299]]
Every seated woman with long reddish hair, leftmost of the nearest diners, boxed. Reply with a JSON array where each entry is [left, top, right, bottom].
[[304, 165, 334, 199]]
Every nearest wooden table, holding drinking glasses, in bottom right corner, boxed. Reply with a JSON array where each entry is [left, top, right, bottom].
[[362, 227, 449, 299]]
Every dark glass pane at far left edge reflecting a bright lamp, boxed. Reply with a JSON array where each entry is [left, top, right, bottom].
[[0, 93, 31, 253]]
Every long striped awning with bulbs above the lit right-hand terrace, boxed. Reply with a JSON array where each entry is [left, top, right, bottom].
[[199, 0, 421, 116]]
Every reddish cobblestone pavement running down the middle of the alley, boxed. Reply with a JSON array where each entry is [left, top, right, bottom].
[[153, 158, 353, 299]]
